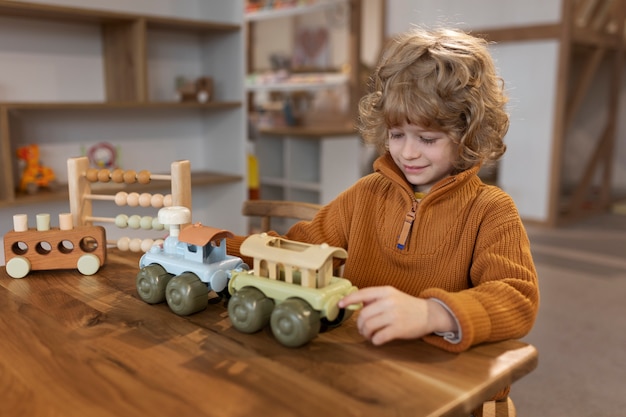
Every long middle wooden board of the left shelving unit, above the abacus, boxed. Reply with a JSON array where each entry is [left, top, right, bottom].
[[0, 101, 242, 111]]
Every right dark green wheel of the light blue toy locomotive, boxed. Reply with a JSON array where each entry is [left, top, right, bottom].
[[165, 272, 209, 316]]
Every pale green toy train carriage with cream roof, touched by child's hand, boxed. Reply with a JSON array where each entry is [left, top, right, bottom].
[[228, 233, 360, 347]]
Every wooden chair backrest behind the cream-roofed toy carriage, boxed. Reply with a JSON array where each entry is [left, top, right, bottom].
[[241, 200, 322, 232]]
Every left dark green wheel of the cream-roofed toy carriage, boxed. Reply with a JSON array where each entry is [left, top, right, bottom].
[[228, 287, 274, 333]]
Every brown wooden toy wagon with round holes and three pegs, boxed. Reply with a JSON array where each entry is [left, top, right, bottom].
[[4, 213, 106, 278]]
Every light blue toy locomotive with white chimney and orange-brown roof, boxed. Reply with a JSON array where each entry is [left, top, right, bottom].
[[136, 207, 248, 316]]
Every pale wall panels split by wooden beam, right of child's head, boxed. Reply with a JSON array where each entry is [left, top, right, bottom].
[[386, 0, 561, 222]]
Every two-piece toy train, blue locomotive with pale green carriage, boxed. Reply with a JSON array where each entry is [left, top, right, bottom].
[[136, 207, 358, 347]]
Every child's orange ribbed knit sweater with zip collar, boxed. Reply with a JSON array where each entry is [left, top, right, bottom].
[[228, 154, 539, 352]]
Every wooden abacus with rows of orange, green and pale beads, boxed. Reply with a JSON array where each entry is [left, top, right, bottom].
[[67, 157, 191, 252]]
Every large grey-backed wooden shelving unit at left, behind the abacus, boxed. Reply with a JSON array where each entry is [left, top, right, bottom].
[[0, 0, 246, 234]]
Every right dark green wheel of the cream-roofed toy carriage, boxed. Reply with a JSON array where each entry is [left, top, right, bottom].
[[270, 298, 320, 347]]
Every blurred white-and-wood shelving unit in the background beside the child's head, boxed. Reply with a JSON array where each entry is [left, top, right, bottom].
[[245, 0, 363, 204]]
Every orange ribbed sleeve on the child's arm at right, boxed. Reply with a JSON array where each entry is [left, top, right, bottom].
[[420, 192, 539, 352]]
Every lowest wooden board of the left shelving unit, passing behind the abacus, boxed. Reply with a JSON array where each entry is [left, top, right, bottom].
[[0, 171, 243, 208]]
